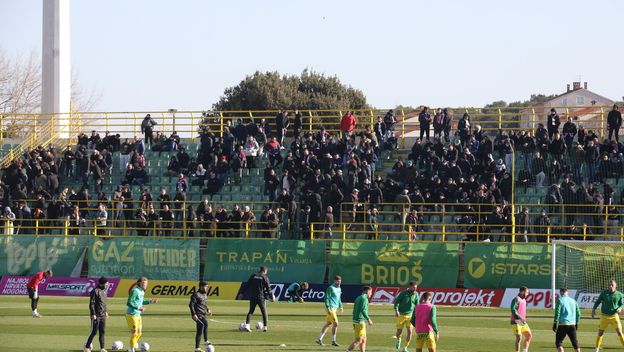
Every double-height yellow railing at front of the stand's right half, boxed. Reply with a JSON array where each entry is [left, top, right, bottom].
[[332, 202, 624, 242]]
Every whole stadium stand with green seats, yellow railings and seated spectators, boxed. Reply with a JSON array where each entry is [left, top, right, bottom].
[[0, 108, 624, 242]]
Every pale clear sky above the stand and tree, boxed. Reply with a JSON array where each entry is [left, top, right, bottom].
[[0, 0, 624, 111]]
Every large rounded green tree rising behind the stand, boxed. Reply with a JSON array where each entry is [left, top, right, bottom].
[[213, 69, 368, 110]]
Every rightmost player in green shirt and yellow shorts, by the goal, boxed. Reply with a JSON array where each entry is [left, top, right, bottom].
[[592, 280, 624, 352]]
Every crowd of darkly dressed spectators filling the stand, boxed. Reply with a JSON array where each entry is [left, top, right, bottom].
[[0, 106, 624, 241]]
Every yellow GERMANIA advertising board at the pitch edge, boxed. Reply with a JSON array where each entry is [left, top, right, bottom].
[[115, 279, 241, 300]]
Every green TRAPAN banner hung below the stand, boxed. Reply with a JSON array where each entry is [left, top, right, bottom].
[[204, 239, 325, 283]]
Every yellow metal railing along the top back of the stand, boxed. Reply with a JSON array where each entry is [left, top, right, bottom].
[[0, 106, 612, 145]]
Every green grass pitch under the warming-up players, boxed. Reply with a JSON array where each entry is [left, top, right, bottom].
[[0, 296, 622, 352]]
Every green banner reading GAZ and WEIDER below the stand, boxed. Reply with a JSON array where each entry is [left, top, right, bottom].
[[89, 237, 199, 280]]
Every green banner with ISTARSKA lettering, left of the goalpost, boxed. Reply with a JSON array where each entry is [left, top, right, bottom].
[[464, 243, 551, 289]]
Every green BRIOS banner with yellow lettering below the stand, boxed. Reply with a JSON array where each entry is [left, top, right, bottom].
[[329, 242, 459, 288]]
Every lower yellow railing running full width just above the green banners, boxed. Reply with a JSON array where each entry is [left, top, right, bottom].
[[3, 219, 624, 243]]
